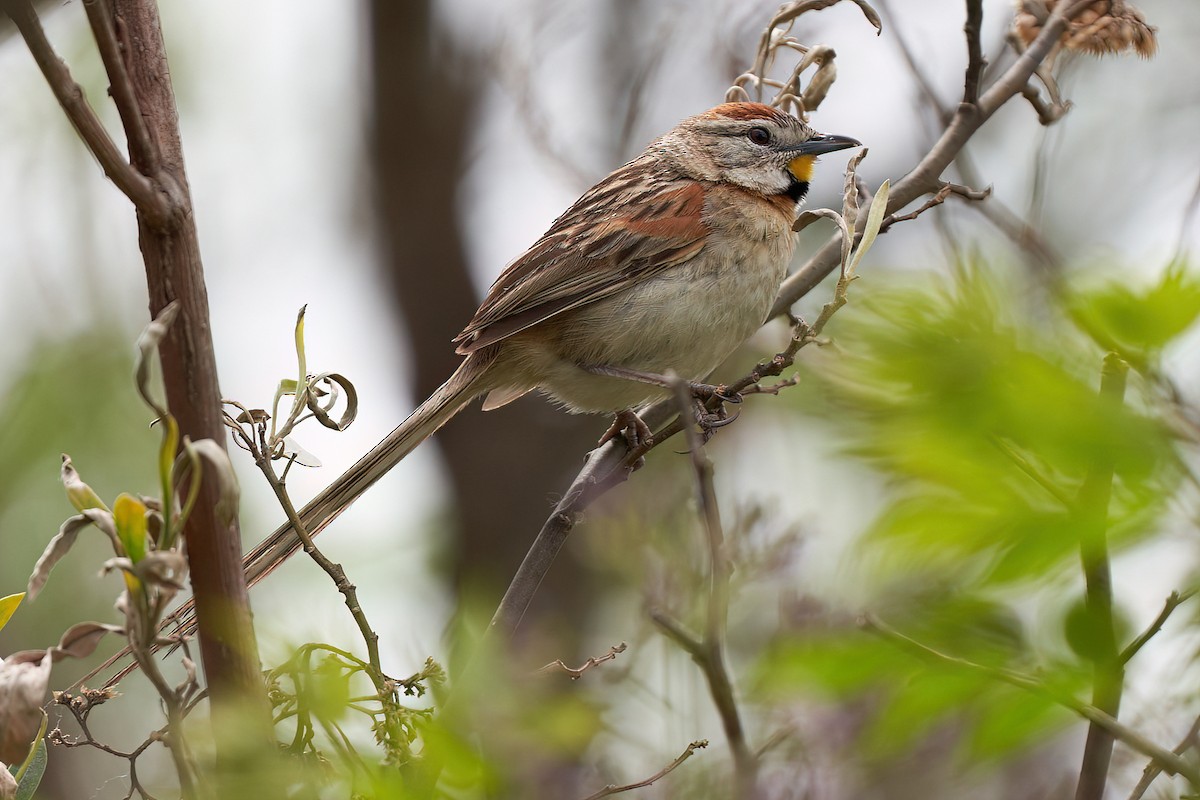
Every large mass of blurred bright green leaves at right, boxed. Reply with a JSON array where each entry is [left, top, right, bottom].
[[756, 264, 1200, 760]]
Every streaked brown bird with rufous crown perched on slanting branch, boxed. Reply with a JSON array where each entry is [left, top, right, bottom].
[[247, 102, 862, 582]]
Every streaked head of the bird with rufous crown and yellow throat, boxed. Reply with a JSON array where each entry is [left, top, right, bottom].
[[652, 103, 862, 203]]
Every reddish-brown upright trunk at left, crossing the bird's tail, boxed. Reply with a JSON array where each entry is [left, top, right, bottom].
[[113, 0, 270, 734]]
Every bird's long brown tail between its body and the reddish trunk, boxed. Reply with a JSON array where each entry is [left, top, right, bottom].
[[242, 357, 490, 585]]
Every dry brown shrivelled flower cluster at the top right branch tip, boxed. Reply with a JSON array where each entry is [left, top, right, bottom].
[[1013, 0, 1158, 59]]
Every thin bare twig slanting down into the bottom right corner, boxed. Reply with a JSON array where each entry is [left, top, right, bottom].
[[859, 615, 1200, 788]]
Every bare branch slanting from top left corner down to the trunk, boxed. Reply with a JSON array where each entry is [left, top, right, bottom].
[[0, 0, 172, 225]]
